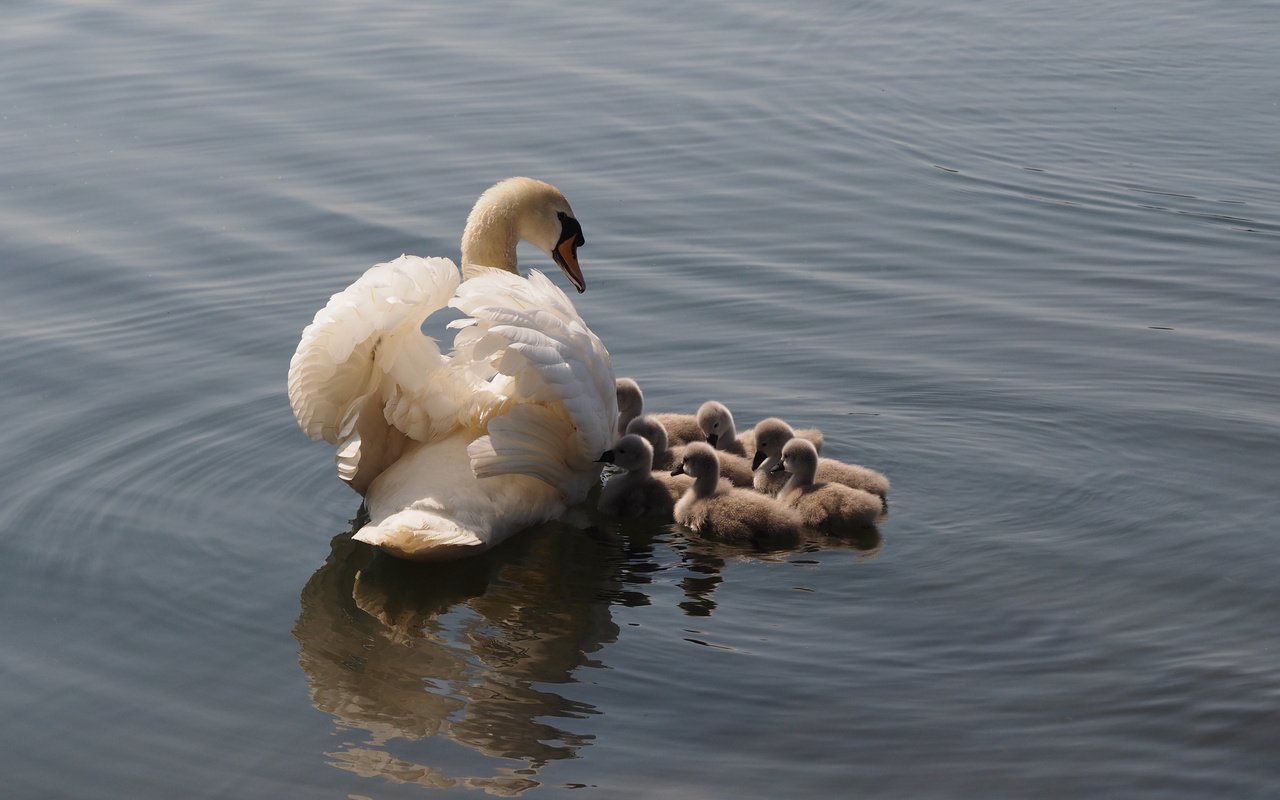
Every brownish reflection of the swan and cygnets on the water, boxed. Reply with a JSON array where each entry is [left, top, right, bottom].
[[293, 515, 881, 795]]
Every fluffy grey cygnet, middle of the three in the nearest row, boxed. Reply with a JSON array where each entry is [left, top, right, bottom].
[[675, 442, 800, 540]]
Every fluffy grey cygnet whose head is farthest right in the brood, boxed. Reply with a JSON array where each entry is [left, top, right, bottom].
[[773, 439, 882, 532]]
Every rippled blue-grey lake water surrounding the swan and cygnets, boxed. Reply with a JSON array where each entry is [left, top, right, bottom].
[[0, 0, 1280, 799]]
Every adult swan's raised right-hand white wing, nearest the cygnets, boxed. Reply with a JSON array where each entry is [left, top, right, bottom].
[[451, 270, 617, 493]]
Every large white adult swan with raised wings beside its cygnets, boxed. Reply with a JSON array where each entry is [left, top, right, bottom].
[[289, 178, 617, 561]]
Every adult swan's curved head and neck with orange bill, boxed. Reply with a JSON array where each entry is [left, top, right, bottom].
[[462, 178, 586, 292]]
